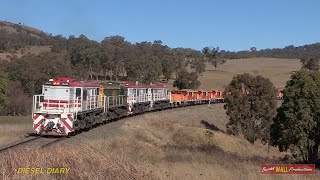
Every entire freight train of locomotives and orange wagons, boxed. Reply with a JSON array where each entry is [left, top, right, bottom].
[[32, 78, 282, 136]]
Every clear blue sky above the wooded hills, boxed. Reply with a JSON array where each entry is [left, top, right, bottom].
[[0, 0, 320, 51]]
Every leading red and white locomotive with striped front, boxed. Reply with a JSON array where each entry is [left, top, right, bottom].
[[32, 78, 105, 135]]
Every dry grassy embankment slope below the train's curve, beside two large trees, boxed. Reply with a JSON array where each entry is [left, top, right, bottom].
[[103, 104, 319, 179]]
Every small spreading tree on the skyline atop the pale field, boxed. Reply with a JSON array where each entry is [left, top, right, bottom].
[[202, 47, 227, 68]]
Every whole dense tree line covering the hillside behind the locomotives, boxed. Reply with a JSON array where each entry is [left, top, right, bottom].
[[0, 22, 225, 115]]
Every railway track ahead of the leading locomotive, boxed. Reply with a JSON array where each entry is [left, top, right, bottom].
[[0, 136, 66, 153]]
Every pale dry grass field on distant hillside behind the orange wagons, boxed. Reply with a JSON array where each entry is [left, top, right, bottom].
[[199, 58, 301, 89]]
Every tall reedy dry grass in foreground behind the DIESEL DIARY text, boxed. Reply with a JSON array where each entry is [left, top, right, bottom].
[[0, 145, 155, 180]]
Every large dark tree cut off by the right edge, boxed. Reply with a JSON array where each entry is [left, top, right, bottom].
[[271, 70, 320, 163]]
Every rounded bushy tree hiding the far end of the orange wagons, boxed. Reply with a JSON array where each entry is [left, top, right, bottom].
[[224, 73, 277, 143]]
